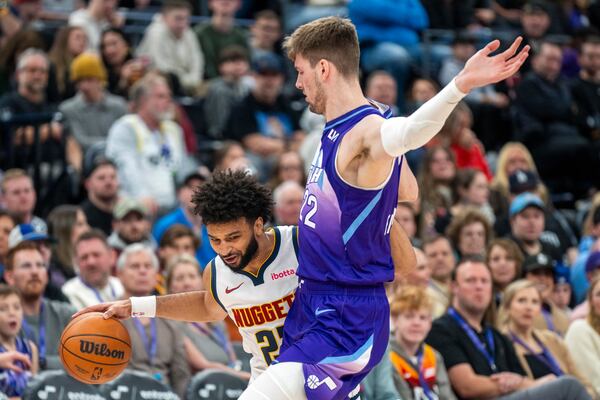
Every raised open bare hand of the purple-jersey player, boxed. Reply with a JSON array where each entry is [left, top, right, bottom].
[[456, 36, 530, 93]]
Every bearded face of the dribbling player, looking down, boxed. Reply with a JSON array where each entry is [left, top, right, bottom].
[[206, 218, 258, 271]]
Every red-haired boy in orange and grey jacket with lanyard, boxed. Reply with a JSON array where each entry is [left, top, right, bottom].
[[390, 286, 456, 400]]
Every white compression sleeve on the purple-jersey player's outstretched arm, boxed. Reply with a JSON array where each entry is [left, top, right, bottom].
[[381, 79, 466, 157]]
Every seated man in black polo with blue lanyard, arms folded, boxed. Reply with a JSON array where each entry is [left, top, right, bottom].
[[425, 259, 590, 400]]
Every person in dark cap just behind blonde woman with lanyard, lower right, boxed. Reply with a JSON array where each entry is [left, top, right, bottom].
[[522, 253, 569, 336]]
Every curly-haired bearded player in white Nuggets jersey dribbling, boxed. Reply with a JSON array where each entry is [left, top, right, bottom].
[[74, 171, 414, 379]]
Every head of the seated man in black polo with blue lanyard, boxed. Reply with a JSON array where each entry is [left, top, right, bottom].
[[452, 262, 492, 314]]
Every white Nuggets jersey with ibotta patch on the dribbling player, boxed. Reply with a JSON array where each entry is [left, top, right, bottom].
[[210, 226, 298, 379]]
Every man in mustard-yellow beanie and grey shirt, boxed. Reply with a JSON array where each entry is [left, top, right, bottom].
[[59, 53, 127, 153]]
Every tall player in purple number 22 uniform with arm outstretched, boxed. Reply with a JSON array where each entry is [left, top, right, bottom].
[[240, 17, 529, 400]]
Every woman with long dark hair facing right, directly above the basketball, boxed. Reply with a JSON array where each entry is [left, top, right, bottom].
[[48, 204, 90, 287]]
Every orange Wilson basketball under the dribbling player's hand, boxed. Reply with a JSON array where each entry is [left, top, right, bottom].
[[59, 312, 131, 384]]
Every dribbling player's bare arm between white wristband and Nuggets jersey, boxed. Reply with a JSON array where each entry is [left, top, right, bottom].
[[156, 291, 216, 322]]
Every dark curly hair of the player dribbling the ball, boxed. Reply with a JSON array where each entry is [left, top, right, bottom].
[[192, 170, 273, 224]]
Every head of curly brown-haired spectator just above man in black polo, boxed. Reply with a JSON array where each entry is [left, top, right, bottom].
[[446, 208, 494, 258]]
